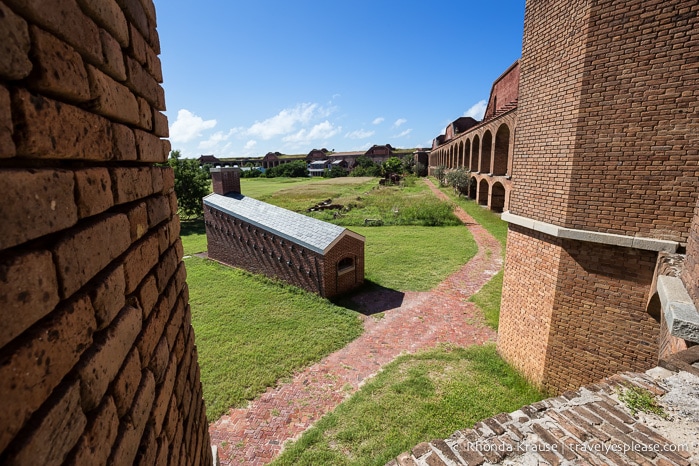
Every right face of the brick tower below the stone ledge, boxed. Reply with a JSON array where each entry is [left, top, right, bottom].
[[544, 240, 659, 391]]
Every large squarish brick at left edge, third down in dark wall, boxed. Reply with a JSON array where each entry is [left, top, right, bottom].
[[0, 169, 78, 249]]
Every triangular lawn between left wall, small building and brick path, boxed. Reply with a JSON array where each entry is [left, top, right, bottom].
[[186, 257, 362, 420]]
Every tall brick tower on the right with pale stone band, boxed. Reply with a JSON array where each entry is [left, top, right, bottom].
[[499, 0, 699, 391]]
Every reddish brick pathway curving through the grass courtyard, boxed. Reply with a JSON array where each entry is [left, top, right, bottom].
[[209, 180, 502, 465]]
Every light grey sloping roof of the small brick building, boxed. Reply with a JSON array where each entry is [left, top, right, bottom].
[[204, 193, 363, 254]]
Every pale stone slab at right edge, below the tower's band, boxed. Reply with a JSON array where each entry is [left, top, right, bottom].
[[658, 275, 699, 343]]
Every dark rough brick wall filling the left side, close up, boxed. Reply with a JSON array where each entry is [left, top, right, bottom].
[[0, 0, 212, 465]]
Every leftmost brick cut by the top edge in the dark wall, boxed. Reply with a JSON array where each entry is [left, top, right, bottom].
[[5, 0, 102, 63]]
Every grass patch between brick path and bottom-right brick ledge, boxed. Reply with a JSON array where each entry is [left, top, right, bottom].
[[272, 344, 543, 466]]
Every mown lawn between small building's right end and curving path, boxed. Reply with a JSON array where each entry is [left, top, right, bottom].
[[352, 226, 477, 291]]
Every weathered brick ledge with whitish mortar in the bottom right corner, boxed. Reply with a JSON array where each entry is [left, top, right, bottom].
[[386, 372, 699, 466]]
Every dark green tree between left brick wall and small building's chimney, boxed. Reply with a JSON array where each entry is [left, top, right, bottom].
[[168, 150, 210, 218]]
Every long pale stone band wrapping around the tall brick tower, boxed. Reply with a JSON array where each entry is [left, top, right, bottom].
[[501, 212, 678, 252]]
